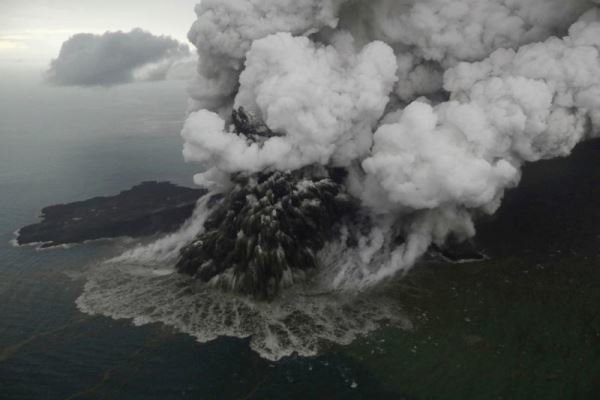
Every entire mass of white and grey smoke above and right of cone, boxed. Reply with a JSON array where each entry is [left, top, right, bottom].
[[180, 0, 600, 286]]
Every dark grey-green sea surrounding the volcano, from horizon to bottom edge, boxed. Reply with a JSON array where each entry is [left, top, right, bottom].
[[0, 70, 600, 400]]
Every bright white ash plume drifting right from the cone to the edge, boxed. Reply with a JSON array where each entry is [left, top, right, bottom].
[[362, 9, 600, 280]]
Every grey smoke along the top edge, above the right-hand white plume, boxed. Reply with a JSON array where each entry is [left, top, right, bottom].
[[340, 0, 590, 100]]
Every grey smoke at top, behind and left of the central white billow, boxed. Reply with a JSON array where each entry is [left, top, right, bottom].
[[188, 0, 345, 110]]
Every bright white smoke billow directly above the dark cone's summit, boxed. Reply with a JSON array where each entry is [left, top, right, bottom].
[[183, 33, 396, 177]]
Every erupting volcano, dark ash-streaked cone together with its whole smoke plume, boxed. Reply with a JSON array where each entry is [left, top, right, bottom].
[[172, 0, 600, 298]]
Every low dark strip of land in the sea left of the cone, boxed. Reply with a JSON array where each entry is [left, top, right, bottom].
[[15, 181, 207, 248]]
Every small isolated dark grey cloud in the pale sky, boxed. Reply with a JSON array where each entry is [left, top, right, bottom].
[[46, 29, 190, 86]]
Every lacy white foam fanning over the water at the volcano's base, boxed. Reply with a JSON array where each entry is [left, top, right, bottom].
[[76, 262, 411, 360]]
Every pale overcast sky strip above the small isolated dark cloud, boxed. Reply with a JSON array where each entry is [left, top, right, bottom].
[[0, 0, 200, 65]]
